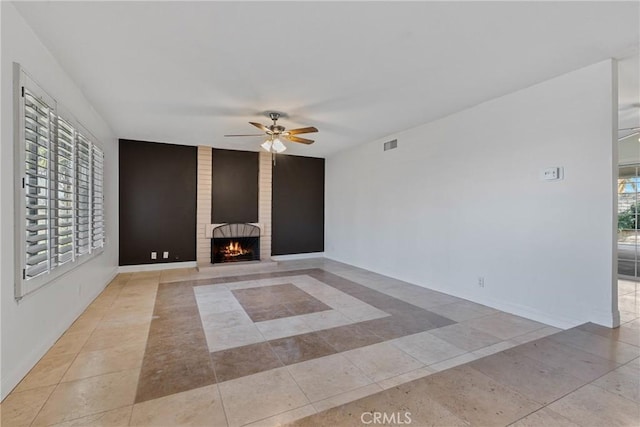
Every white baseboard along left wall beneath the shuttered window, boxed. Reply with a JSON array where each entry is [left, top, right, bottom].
[[0, 268, 118, 402]]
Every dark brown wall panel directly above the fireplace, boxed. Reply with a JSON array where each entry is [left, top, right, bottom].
[[211, 149, 259, 224]]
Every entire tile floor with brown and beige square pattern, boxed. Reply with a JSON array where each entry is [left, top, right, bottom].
[[0, 259, 640, 427]]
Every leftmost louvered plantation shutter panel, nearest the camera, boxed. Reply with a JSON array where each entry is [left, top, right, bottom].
[[23, 88, 55, 279]]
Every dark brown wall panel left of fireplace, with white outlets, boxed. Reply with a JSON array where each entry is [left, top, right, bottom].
[[119, 139, 198, 265]]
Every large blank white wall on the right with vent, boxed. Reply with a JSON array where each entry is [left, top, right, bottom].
[[325, 61, 617, 327]]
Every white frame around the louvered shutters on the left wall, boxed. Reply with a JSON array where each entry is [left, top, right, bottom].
[[13, 63, 106, 300]]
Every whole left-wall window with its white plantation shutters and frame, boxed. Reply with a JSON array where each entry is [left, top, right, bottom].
[[15, 64, 105, 299]]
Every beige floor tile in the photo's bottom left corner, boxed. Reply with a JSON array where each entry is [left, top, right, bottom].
[[0, 386, 55, 427]]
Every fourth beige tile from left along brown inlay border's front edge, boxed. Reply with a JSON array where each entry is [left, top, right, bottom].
[[342, 343, 424, 381]]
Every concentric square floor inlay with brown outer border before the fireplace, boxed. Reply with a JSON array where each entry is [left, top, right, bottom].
[[135, 269, 456, 403]]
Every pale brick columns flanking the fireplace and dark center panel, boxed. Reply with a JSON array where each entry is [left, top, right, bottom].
[[196, 146, 272, 266]]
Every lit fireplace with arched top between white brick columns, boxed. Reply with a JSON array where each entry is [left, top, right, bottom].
[[211, 223, 260, 264]]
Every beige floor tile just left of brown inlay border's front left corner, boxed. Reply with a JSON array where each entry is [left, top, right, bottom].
[[34, 369, 140, 426]]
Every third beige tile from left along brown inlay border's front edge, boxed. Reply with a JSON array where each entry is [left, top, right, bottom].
[[287, 354, 373, 402]]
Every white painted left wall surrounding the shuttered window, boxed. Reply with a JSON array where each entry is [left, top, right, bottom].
[[0, 2, 118, 398]]
